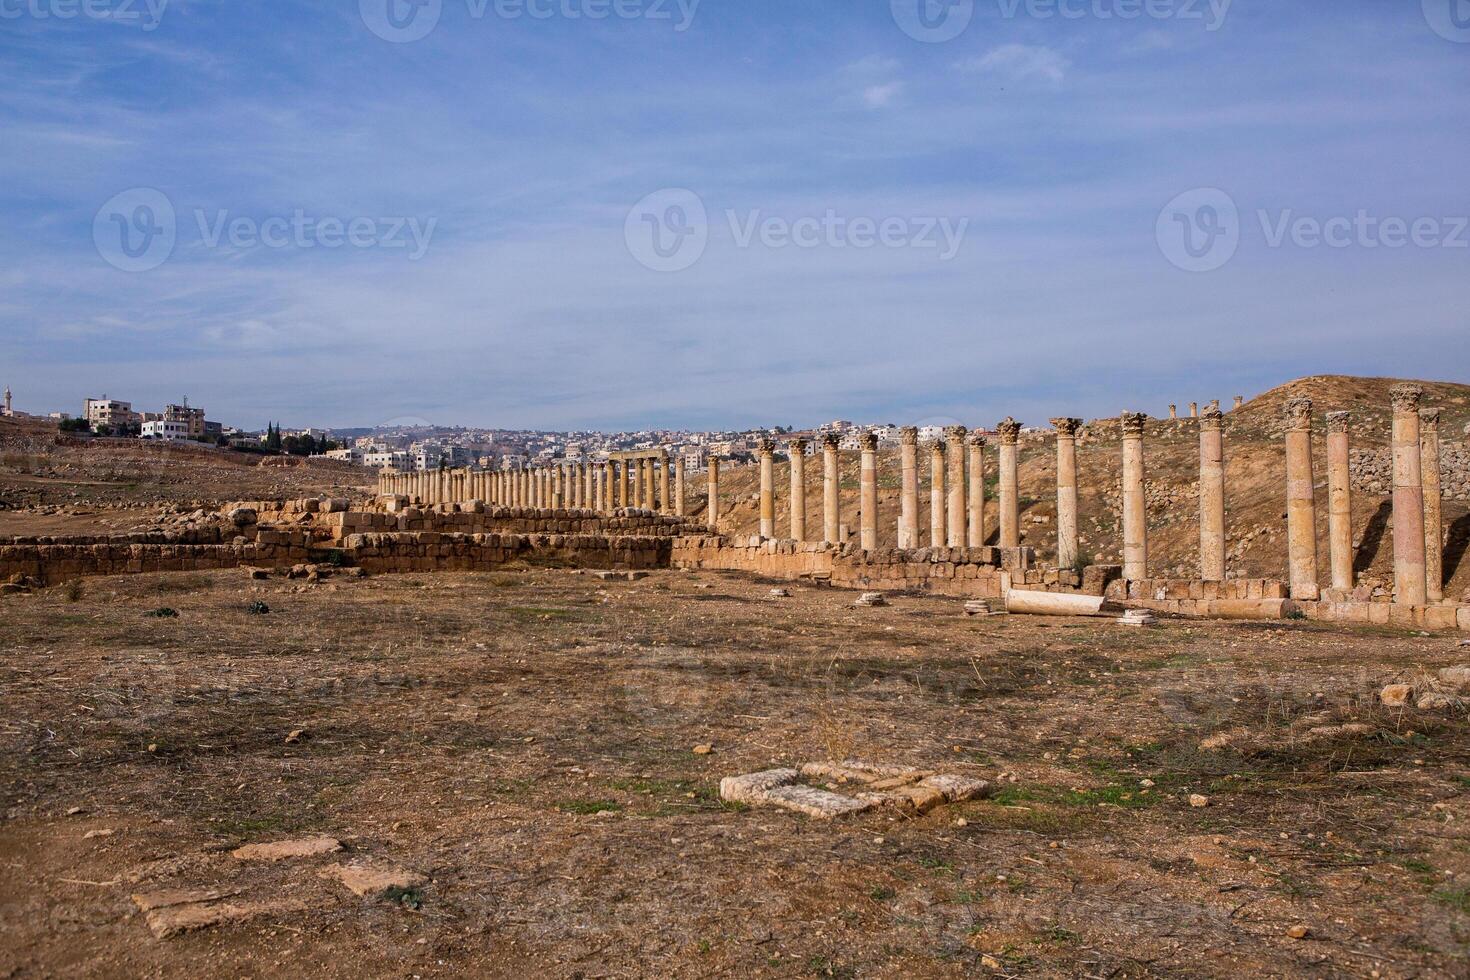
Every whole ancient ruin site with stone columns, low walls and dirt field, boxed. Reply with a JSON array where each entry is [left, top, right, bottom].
[[0, 378, 1470, 977]]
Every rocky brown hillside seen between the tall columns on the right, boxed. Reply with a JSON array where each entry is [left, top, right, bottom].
[[691, 376, 1470, 597]]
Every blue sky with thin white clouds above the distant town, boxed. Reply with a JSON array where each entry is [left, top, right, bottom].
[[0, 0, 1470, 429]]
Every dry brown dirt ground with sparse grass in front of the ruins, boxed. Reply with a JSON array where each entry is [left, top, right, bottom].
[[0, 569, 1470, 977]]
